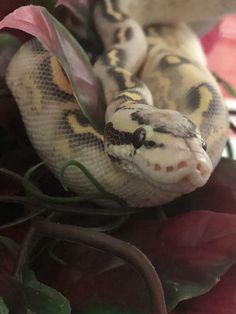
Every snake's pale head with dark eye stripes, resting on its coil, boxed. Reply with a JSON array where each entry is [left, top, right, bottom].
[[105, 106, 213, 194]]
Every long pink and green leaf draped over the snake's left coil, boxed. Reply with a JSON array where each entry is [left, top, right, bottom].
[[0, 6, 104, 131]]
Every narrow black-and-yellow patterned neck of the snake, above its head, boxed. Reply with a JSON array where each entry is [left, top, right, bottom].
[[94, 0, 152, 111]]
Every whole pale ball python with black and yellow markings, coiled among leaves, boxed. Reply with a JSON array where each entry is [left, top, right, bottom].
[[6, 0, 228, 207]]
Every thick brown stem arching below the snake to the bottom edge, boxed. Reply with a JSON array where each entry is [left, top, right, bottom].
[[33, 221, 167, 314]]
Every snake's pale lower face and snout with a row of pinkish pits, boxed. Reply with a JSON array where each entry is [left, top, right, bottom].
[[133, 139, 213, 194]]
